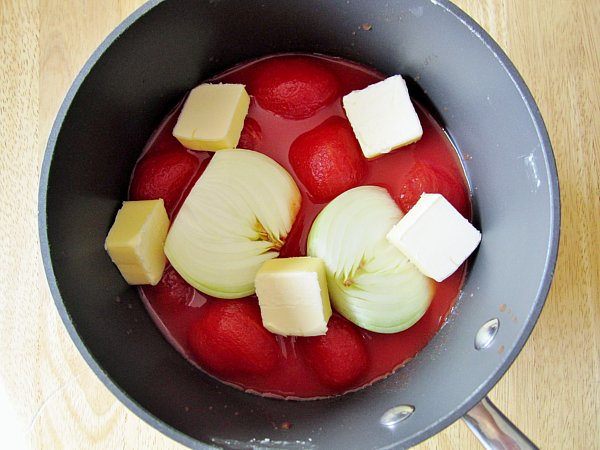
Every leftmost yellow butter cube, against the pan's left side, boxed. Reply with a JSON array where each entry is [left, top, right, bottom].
[[104, 199, 169, 286]]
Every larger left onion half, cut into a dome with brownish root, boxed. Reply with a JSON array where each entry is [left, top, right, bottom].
[[165, 149, 301, 298]]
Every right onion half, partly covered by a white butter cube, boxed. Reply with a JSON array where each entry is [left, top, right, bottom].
[[307, 186, 435, 333]]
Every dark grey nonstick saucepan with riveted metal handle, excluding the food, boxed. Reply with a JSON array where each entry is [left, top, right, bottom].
[[39, 0, 560, 449]]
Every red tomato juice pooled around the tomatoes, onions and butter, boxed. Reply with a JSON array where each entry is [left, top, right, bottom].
[[134, 55, 470, 399]]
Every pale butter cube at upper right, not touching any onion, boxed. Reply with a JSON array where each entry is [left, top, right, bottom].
[[342, 75, 423, 158]]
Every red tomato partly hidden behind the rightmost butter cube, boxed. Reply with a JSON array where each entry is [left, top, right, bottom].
[[397, 161, 468, 216]]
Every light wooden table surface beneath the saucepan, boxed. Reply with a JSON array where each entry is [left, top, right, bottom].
[[0, 0, 600, 449]]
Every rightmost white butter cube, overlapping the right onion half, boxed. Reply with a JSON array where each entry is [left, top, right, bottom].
[[386, 194, 481, 281]]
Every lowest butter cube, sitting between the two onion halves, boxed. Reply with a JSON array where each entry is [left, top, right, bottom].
[[255, 256, 331, 336]]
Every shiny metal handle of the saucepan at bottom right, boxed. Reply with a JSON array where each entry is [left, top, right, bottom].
[[463, 397, 538, 450]]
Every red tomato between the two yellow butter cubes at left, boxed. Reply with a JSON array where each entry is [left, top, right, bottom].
[[129, 149, 200, 214]]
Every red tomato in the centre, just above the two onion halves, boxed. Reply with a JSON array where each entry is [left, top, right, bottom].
[[289, 117, 366, 202]]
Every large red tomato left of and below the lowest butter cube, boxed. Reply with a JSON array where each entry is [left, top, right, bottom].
[[188, 299, 280, 375]]
